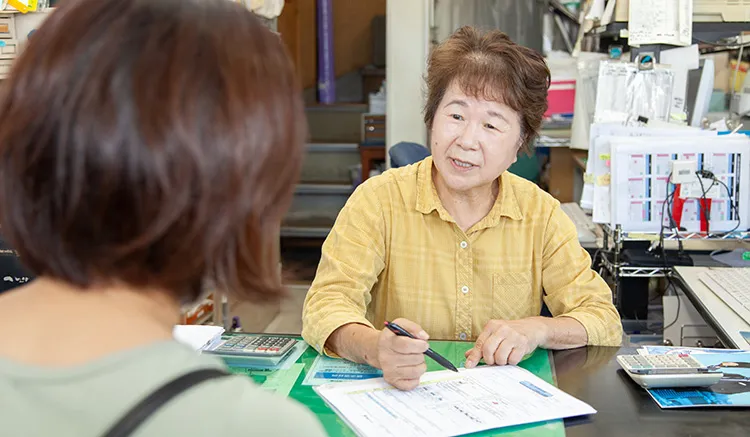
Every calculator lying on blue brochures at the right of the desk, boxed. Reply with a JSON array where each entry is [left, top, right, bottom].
[[617, 355, 724, 388]]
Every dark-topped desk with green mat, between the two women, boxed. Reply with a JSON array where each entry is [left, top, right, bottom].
[[229, 341, 750, 437]]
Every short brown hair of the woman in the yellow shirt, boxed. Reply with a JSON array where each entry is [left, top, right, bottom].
[[424, 26, 550, 152]]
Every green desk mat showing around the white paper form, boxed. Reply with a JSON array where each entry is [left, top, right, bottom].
[[232, 341, 565, 437]]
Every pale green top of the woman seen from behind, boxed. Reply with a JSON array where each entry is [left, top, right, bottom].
[[0, 337, 325, 437]]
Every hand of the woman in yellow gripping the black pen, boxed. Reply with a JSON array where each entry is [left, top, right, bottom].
[[378, 319, 430, 390]]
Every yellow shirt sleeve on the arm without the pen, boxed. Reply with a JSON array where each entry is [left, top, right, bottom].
[[542, 204, 622, 346]]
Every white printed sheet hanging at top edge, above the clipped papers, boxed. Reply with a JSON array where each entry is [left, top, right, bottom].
[[628, 0, 693, 46]]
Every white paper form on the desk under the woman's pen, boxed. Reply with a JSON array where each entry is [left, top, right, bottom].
[[315, 366, 596, 437]]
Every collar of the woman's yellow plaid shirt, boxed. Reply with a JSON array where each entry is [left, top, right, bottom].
[[416, 157, 523, 228]]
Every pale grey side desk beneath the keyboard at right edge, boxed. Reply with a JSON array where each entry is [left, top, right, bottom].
[[673, 266, 750, 348]]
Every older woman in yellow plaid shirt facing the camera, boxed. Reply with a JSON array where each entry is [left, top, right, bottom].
[[303, 27, 622, 389]]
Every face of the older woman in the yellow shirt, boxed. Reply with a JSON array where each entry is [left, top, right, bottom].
[[431, 83, 522, 192]]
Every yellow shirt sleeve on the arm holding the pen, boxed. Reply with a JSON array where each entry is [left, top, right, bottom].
[[302, 182, 385, 357]]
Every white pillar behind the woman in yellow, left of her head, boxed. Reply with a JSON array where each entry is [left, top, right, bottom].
[[385, 0, 433, 165]]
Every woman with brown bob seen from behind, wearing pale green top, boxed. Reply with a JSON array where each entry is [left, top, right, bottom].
[[0, 0, 323, 437]]
